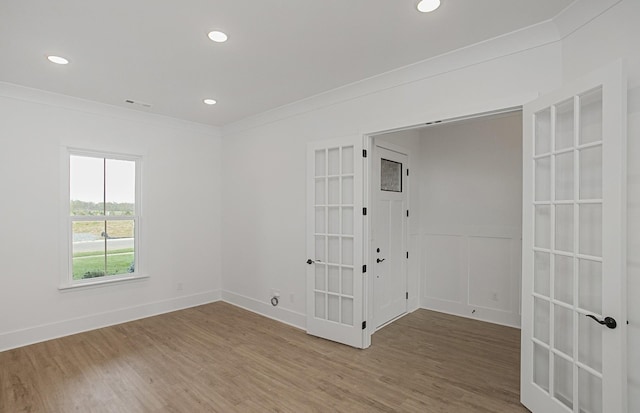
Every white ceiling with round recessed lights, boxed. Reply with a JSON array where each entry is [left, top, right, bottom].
[[0, 0, 572, 126]]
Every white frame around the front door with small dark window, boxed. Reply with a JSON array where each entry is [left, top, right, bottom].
[[365, 140, 408, 334]]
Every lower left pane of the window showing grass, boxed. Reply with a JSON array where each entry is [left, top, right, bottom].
[[71, 221, 106, 280]]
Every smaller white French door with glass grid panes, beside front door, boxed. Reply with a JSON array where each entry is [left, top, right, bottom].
[[307, 137, 363, 348]]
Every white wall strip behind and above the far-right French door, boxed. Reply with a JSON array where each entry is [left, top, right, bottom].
[[562, 0, 640, 412]]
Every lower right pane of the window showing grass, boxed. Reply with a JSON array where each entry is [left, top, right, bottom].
[[106, 221, 135, 275]]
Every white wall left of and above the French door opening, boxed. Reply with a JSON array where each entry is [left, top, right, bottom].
[[222, 39, 561, 328]]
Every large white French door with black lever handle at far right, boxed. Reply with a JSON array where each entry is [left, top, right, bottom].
[[521, 63, 627, 413]]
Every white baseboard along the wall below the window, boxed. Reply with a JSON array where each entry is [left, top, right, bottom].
[[0, 290, 222, 352]]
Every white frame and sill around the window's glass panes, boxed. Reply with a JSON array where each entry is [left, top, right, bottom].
[[58, 147, 148, 290]]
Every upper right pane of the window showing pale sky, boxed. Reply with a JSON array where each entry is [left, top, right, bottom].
[[105, 159, 136, 216]]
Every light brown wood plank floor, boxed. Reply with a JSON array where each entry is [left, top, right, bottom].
[[0, 302, 527, 413]]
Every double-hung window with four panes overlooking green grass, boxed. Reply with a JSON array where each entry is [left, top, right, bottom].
[[63, 151, 140, 288]]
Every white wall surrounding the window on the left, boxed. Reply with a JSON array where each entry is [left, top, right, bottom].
[[0, 83, 221, 351]]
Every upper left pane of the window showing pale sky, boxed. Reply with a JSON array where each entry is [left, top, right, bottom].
[[69, 155, 104, 215]]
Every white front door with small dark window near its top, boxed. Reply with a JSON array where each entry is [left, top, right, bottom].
[[372, 145, 408, 328]]
